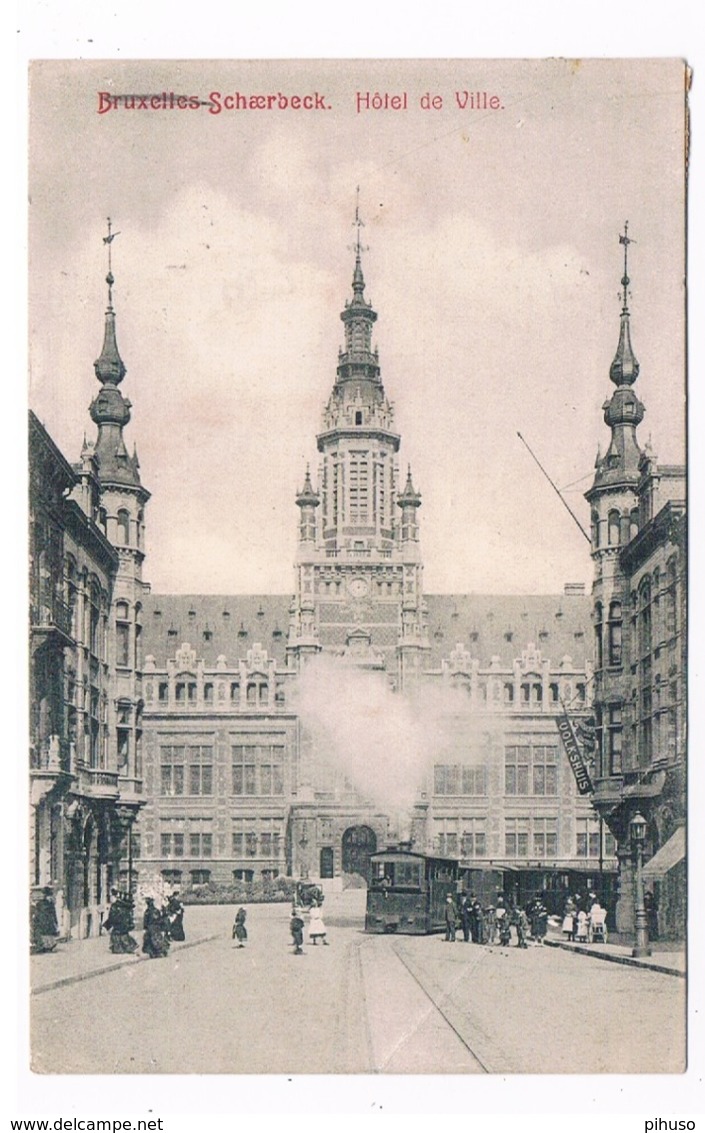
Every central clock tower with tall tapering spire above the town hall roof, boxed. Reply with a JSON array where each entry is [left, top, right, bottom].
[[288, 213, 428, 688]]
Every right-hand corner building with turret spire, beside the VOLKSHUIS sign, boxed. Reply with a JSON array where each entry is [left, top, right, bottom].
[[586, 230, 687, 937]]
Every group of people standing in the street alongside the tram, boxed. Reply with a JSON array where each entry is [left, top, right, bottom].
[[444, 893, 549, 948]]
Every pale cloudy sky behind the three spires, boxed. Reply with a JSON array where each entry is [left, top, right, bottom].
[[29, 60, 685, 594]]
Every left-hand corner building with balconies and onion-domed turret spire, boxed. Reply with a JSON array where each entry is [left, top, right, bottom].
[[29, 257, 148, 936]]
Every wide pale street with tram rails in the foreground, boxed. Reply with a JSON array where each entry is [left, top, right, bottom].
[[32, 894, 686, 1074]]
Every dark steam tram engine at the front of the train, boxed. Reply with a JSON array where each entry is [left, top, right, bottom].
[[365, 847, 458, 936]]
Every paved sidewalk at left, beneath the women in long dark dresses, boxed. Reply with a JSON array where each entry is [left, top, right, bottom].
[[29, 906, 221, 995]]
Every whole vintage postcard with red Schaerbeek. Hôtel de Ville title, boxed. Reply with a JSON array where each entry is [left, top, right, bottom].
[[27, 59, 689, 1076]]
